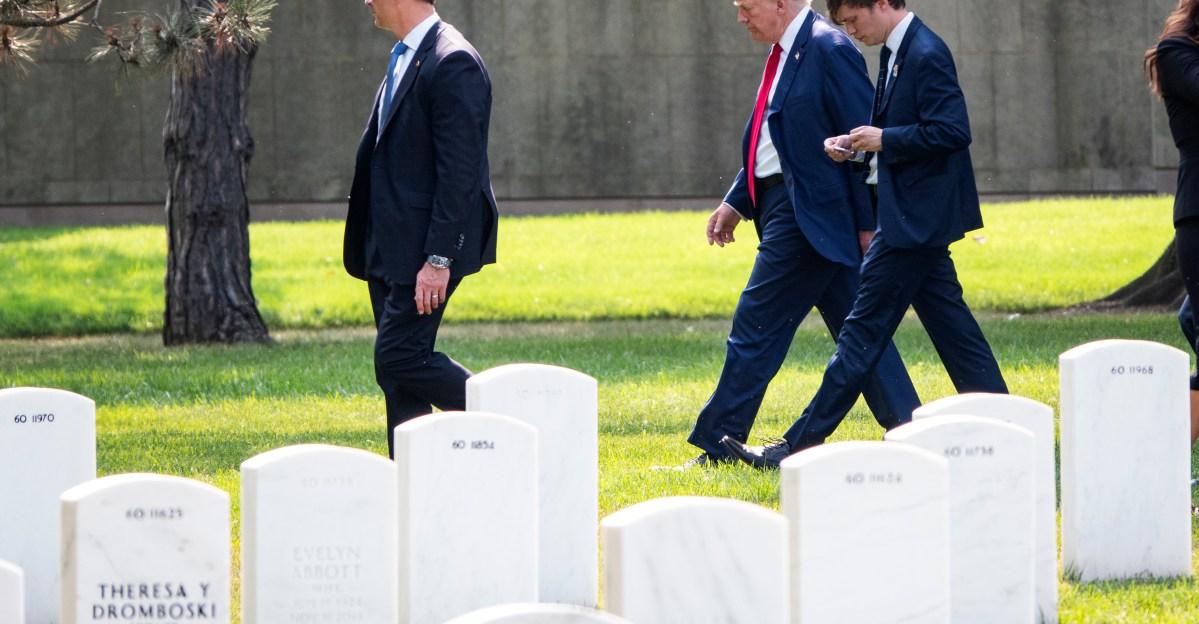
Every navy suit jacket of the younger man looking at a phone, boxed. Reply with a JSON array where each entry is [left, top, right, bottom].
[[872, 17, 982, 248]]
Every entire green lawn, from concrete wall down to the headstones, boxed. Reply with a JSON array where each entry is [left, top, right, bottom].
[[0, 198, 1199, 623]]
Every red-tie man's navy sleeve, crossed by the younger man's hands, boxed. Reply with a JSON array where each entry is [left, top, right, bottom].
[[821, 41, 875, 232]]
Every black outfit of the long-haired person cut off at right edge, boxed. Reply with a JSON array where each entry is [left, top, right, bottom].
[[1157, 37, 1199, 390]]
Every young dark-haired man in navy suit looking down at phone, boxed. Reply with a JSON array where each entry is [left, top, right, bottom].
[[725, 0, 1007, 468]]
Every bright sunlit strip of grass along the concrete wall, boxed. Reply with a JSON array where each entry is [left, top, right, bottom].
[[0, 197, 1173, 337]]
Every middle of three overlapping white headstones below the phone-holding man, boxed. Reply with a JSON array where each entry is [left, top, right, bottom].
[[886, 415, 1036, 624]]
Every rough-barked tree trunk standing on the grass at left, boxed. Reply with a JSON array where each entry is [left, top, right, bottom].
[[163, 7, 270, 346]]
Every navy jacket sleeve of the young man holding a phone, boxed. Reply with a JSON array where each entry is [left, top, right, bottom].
[[882, 41, 971, 163]]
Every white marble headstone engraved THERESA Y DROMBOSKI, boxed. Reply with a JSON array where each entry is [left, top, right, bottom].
[[62, 474, 230, 624]]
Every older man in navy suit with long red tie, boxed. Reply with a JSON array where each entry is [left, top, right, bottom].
[[687, 0, 920, 467]]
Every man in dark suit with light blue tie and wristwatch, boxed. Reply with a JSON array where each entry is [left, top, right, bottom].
[[343, 0, 499, 457]]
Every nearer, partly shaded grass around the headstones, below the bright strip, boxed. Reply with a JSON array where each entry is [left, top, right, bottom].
[[0, 313, 1199, 623]]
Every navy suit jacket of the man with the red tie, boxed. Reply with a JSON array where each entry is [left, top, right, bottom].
[[724, 11, 875, 266]]
